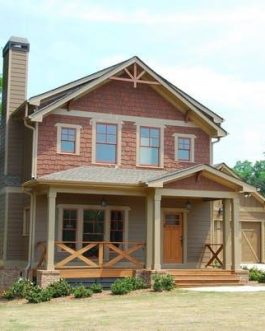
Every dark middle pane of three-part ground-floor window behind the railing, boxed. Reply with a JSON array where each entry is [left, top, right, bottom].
[[83, 209, 105, 257]]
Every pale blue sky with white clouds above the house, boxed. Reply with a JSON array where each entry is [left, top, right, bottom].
[[0, 0, 265, 166]]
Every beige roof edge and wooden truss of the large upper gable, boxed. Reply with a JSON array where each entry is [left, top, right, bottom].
[[26, 57, 226, 137]]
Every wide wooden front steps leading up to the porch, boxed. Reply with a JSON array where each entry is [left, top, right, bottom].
[[166, 269, 247, 288]]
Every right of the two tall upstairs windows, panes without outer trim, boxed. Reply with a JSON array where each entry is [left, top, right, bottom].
[[139, 126, 160, 167]]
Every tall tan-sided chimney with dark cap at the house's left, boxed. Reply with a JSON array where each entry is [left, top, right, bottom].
[[0, 37, 29, 186]]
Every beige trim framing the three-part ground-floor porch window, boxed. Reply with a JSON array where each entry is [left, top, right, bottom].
[[57, 204, 131, 252]]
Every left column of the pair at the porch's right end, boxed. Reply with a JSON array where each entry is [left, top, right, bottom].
[[223, 199, 231, 270]]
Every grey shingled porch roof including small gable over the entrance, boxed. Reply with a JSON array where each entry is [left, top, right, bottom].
[[24, 164, 257, 197]]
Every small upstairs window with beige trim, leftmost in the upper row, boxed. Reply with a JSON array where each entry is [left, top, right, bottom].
[[56, 123, 81, 154]]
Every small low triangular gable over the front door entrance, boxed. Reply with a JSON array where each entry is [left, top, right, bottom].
[[148, 165, 256, 192]]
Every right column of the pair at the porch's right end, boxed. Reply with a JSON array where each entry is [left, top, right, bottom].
[[232, 198, 241, 270]]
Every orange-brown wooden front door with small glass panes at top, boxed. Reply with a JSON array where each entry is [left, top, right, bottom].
[[163, 212, 183, 263]]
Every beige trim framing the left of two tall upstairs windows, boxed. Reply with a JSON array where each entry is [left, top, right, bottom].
[[90, 118, 123, 166]]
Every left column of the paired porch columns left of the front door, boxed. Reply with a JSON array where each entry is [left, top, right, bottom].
[[145, 195, 154, 270]]
